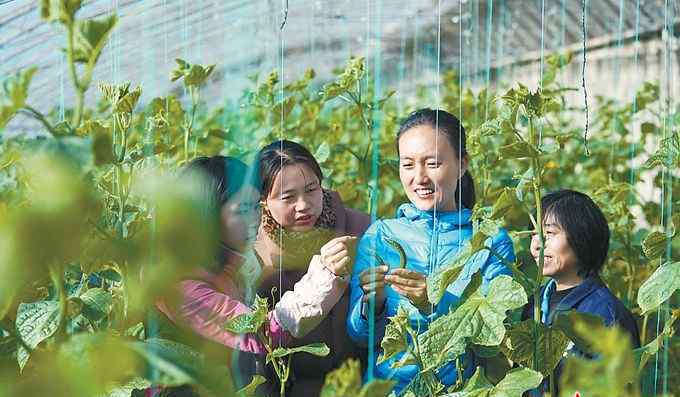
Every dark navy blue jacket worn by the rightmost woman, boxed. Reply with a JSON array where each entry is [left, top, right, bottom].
[[523, 276, 640, 391]]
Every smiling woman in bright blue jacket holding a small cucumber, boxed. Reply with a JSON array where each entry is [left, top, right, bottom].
[[347, 109, 515, 392]]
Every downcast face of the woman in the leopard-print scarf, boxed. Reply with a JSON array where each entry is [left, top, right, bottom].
[[266, 163, 323, 232]]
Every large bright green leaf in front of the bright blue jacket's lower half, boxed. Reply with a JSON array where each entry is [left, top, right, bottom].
[[418, 275, 527, 369]]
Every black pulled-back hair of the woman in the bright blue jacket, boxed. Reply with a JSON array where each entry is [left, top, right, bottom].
[[397, 108, 476, 209]]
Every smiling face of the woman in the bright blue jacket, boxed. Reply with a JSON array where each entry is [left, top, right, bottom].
[[399, 124, 467, 211]]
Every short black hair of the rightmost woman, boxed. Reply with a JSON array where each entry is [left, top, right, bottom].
[[541, 189, 610, 277]]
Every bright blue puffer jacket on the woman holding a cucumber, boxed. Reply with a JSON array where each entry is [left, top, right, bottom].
[[347, 203, 515, 392]]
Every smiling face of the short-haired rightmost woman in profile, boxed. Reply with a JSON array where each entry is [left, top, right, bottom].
[[531, 215, 583, 290]]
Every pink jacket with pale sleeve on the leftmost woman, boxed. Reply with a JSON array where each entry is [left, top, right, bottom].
[[157, 249, 347, 354]]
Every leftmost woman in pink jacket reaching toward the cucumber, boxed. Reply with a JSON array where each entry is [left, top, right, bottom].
[[157, 156, 353, 392]]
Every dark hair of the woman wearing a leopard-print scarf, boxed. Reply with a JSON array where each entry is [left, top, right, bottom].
[[257, 139, 323, 199]]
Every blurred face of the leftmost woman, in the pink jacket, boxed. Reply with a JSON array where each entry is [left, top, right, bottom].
[[220, 185, 260, 252]]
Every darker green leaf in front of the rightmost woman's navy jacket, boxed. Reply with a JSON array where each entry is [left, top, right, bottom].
[[501, 319, 569, 376]]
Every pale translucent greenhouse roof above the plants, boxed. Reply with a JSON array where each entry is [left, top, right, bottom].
[[0, 0, 680, 119]]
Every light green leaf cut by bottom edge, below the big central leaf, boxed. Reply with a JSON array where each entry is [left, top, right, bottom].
[[443, 367, 543, 397]]
